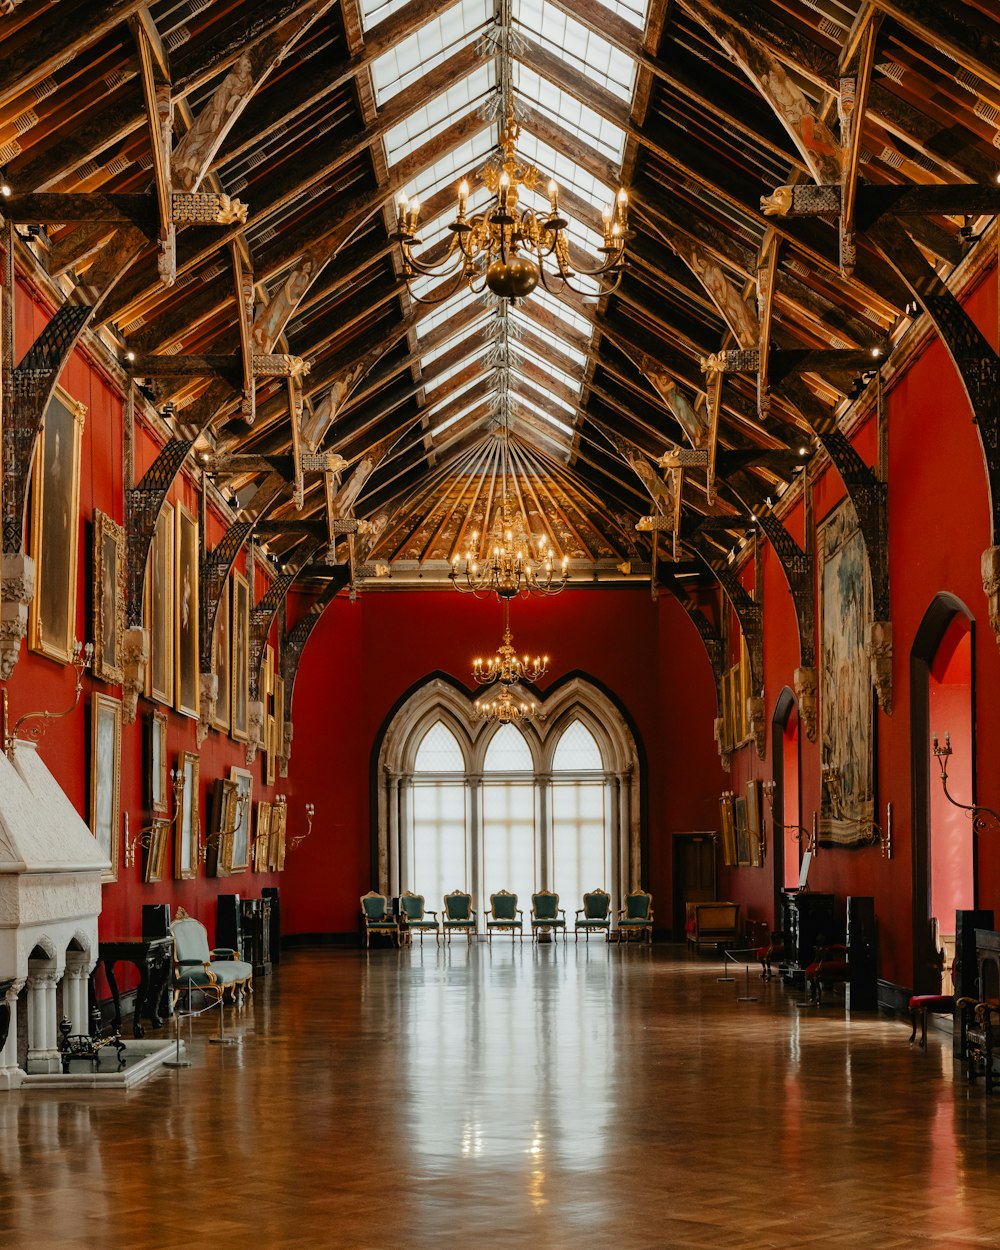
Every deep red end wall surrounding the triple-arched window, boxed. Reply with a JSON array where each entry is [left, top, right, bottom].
[[283, 586, 723, 933]]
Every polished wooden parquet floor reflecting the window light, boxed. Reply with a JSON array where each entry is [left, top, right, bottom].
[[0, 939, 1000, 1250]]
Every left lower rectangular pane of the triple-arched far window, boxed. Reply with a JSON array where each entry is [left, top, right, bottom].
[[410, 775, 470, 913]]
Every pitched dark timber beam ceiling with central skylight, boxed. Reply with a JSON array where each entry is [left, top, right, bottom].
[[0, 0, 1000, 595]]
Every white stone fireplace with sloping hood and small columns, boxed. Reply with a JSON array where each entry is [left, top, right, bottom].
[[0, 741, 110, 1090]]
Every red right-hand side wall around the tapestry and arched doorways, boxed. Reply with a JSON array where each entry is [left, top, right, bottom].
[[720, 258, 1000, 986]]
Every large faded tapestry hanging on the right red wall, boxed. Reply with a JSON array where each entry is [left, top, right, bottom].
[[818, 499, 875, 846]]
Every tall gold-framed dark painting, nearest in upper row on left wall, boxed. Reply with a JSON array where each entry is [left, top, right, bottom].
[[29, 386, 86, 664]]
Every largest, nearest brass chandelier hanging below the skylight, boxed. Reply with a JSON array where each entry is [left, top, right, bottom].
[[393, 0, 630, 304]]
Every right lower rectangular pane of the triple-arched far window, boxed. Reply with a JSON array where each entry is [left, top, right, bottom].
[[550, 781, 611, 915]]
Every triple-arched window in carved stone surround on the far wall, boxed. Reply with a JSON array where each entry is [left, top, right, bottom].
[[378, 678, 641, 924]]
